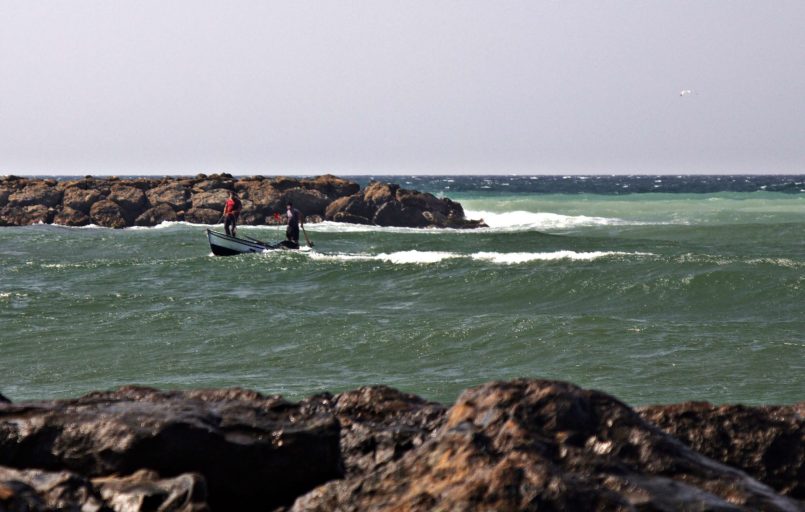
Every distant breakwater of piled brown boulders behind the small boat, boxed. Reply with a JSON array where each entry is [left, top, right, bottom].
[[0, 174, 485, 229]]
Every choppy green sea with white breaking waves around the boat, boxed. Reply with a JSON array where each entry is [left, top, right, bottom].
[[0, 175, 805, 405]]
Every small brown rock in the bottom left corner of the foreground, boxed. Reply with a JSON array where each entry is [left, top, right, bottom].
[[0, 466, 112, 512]]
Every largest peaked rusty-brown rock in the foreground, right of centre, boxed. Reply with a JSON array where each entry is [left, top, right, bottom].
[[291, 380, 801, 511]]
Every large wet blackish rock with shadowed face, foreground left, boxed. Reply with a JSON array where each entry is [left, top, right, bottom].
[[0, 387, 342, 510]]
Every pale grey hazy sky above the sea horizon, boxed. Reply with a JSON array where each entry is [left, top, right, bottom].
[[0, 0, 805, 175]]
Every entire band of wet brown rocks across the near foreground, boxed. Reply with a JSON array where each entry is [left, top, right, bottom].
[[0, 379, 805, 511]]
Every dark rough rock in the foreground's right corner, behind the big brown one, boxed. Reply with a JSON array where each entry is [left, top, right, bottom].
[[637, 402, 805, 500]]
